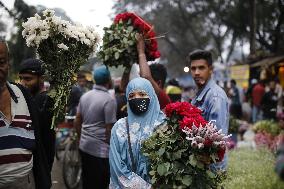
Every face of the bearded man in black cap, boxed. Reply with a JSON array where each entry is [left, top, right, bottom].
[[19, 73, 41, 95]]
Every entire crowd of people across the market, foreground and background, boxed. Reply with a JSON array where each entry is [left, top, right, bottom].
[[0, 32, 282, 189]]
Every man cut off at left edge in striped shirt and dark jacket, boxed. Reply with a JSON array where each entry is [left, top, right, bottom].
[[0, 39, 51, 189]]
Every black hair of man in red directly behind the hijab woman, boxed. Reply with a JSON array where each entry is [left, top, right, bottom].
[[149, 63, 168, 87]]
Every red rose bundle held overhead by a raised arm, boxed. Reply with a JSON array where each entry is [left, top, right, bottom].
[[98, 12, 161, 67]]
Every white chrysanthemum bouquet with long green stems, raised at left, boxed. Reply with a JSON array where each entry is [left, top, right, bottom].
[[22, 9, 100, 127]]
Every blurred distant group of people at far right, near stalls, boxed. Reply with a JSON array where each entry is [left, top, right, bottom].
[[214, 78, 284, 123]]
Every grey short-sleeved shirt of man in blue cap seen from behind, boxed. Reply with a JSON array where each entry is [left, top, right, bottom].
[[77, 85, 116, 158]]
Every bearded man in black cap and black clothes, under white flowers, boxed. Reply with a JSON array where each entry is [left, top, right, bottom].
[[19, 59, 55, 171]]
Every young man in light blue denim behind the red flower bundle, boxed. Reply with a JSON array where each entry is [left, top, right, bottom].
[[189, 50, 229, 170]]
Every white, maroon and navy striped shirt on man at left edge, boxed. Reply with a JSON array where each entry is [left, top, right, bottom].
[[0, 83, 35, 188]]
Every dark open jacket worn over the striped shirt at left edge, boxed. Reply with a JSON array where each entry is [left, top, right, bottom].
[[7, 84, 51, 189]]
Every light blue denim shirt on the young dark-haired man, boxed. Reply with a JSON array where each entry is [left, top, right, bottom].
[[192, 79, 229, 134]]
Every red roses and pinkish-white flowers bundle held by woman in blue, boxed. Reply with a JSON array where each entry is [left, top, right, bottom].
[[142, 102, 229, 188]]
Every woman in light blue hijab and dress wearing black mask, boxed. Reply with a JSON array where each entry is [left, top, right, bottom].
[[109, 77, 165, 189]]
